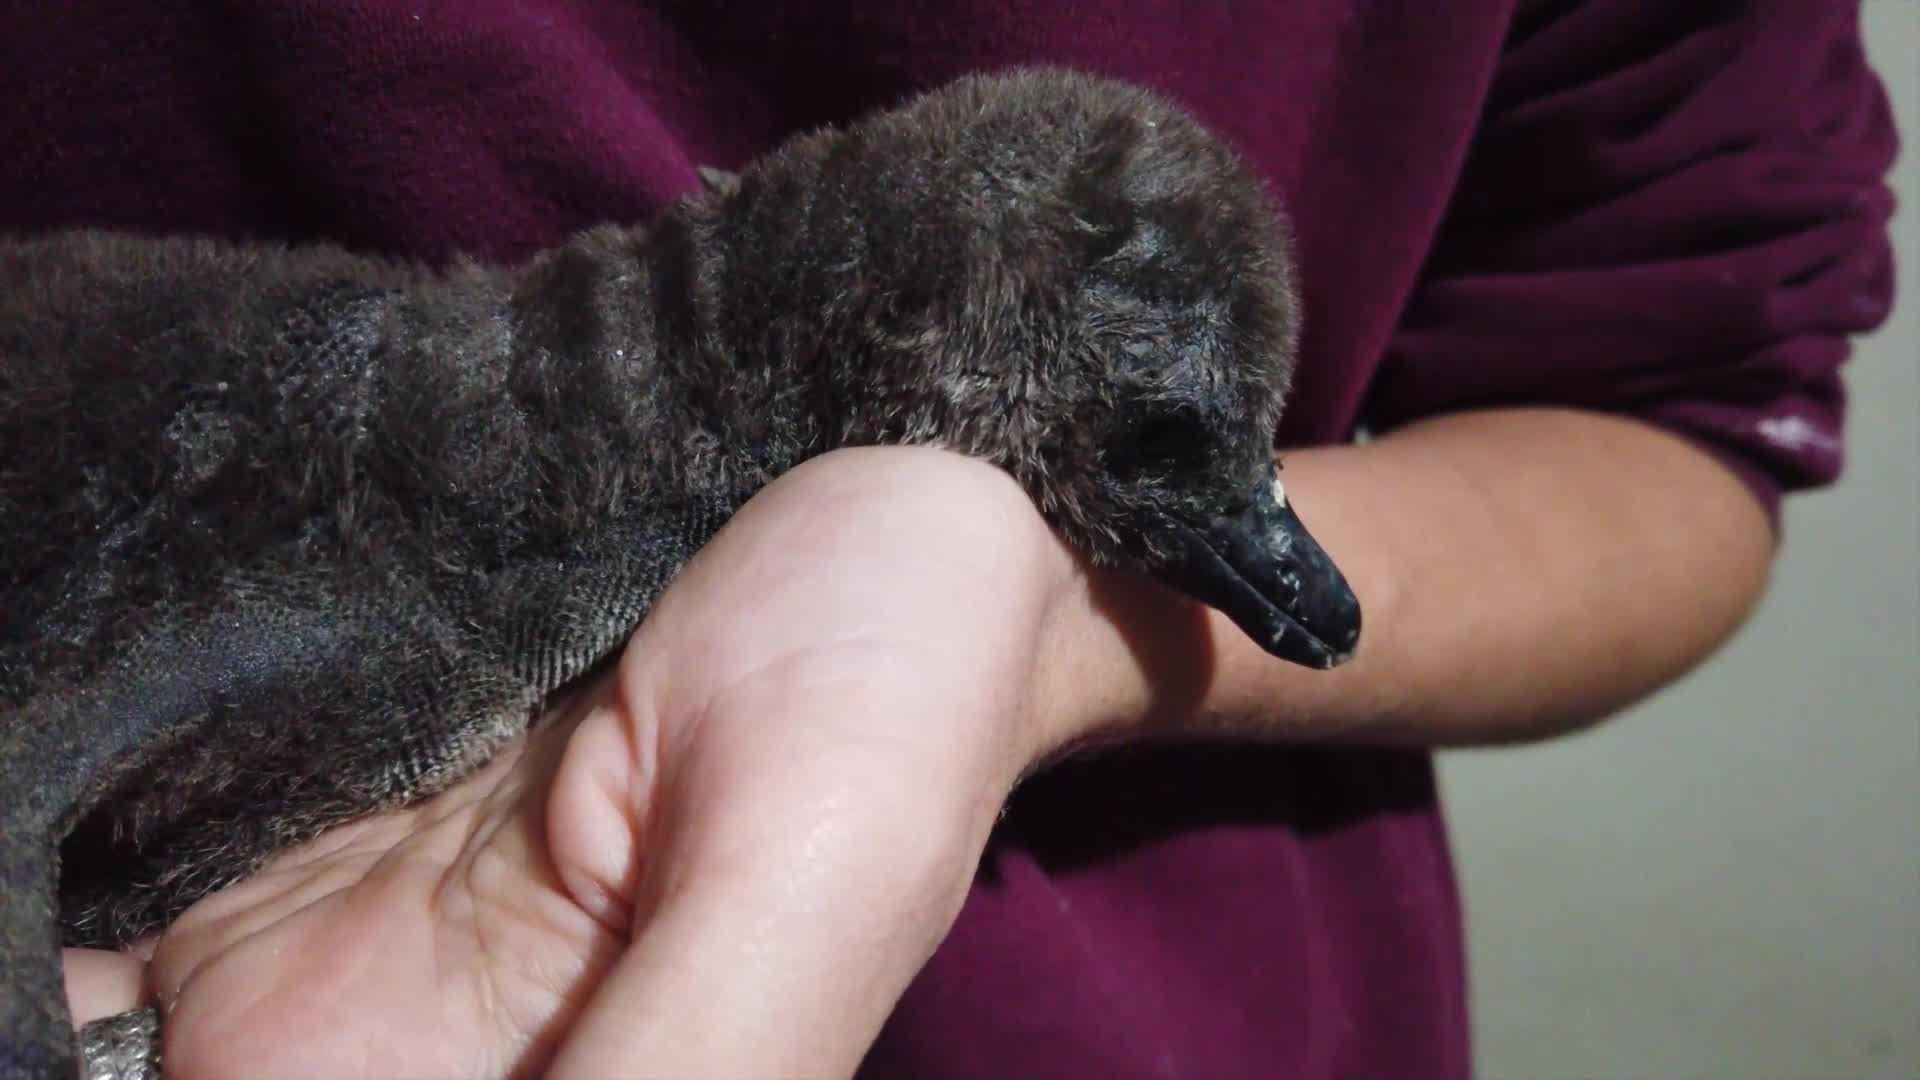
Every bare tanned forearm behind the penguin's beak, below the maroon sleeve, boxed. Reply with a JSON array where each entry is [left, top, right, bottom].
[[1044, 409, 1772, 746]]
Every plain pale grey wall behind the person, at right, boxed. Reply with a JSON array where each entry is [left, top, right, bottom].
[[1442, 0, 1920, 1078]]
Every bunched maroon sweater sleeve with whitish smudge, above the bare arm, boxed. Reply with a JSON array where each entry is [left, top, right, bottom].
[[1367, 0, 1897, 513]]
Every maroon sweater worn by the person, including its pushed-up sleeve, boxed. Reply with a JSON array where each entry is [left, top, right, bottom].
[[0, 0, 1895, 1080]]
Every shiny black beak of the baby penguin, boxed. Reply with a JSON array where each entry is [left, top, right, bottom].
[[1160, 475, 1359, 667]]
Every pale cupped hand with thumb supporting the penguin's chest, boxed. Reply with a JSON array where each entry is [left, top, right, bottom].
[[69, 450, 1079, 1080]]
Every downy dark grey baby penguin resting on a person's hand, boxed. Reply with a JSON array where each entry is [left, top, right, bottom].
[[0, 69, 1359, 1076]]
